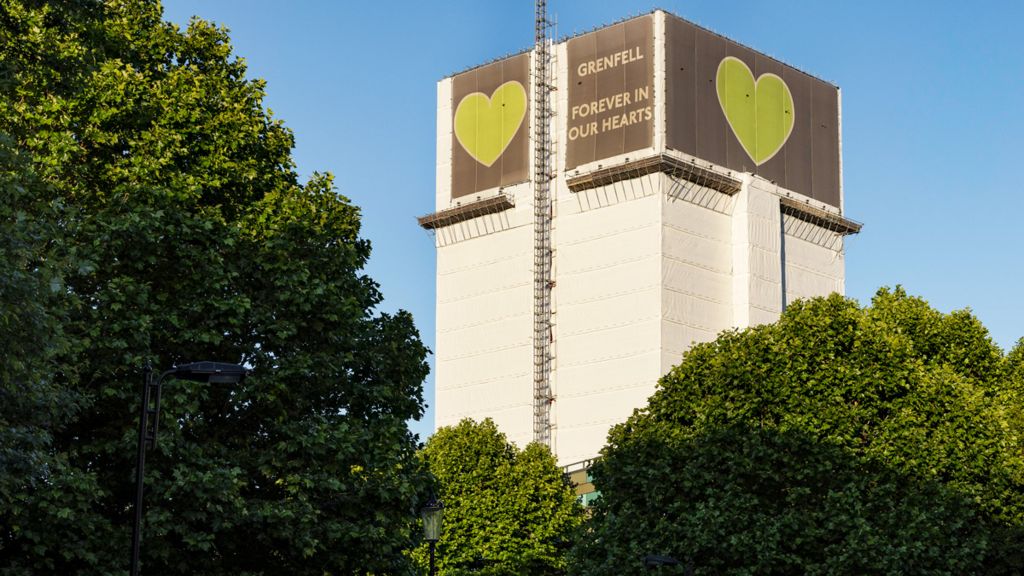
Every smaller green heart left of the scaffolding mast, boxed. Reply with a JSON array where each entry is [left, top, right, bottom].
[[455, 81, 526, 168]]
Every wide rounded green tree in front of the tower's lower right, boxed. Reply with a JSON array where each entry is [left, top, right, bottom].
[[572, 289, 1024, 575]]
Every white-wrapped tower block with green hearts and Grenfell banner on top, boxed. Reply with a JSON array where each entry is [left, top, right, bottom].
[[419, 10, 861, 465]]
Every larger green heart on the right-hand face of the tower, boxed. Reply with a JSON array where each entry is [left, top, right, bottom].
[[715, 56, 796, 166]]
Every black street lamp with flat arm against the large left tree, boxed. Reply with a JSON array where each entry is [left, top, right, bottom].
[[131, 362, 246, 576]]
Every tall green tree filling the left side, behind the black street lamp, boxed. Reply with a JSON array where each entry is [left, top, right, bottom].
[[0, 0, 430, 575]]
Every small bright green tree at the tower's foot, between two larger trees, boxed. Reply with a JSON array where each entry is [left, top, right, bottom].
[[414, 418, 583, 576]]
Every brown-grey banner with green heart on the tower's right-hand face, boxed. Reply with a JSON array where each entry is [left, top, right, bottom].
[[666, 14, 840, 207]]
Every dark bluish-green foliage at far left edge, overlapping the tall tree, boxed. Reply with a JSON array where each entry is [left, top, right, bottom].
[[0, 135, 94, 571]]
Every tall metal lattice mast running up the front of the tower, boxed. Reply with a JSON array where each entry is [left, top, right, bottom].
[[534, 0, 554, 449]]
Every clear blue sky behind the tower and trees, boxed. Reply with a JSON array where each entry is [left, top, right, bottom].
[[164, 0, 1024, 439]]
